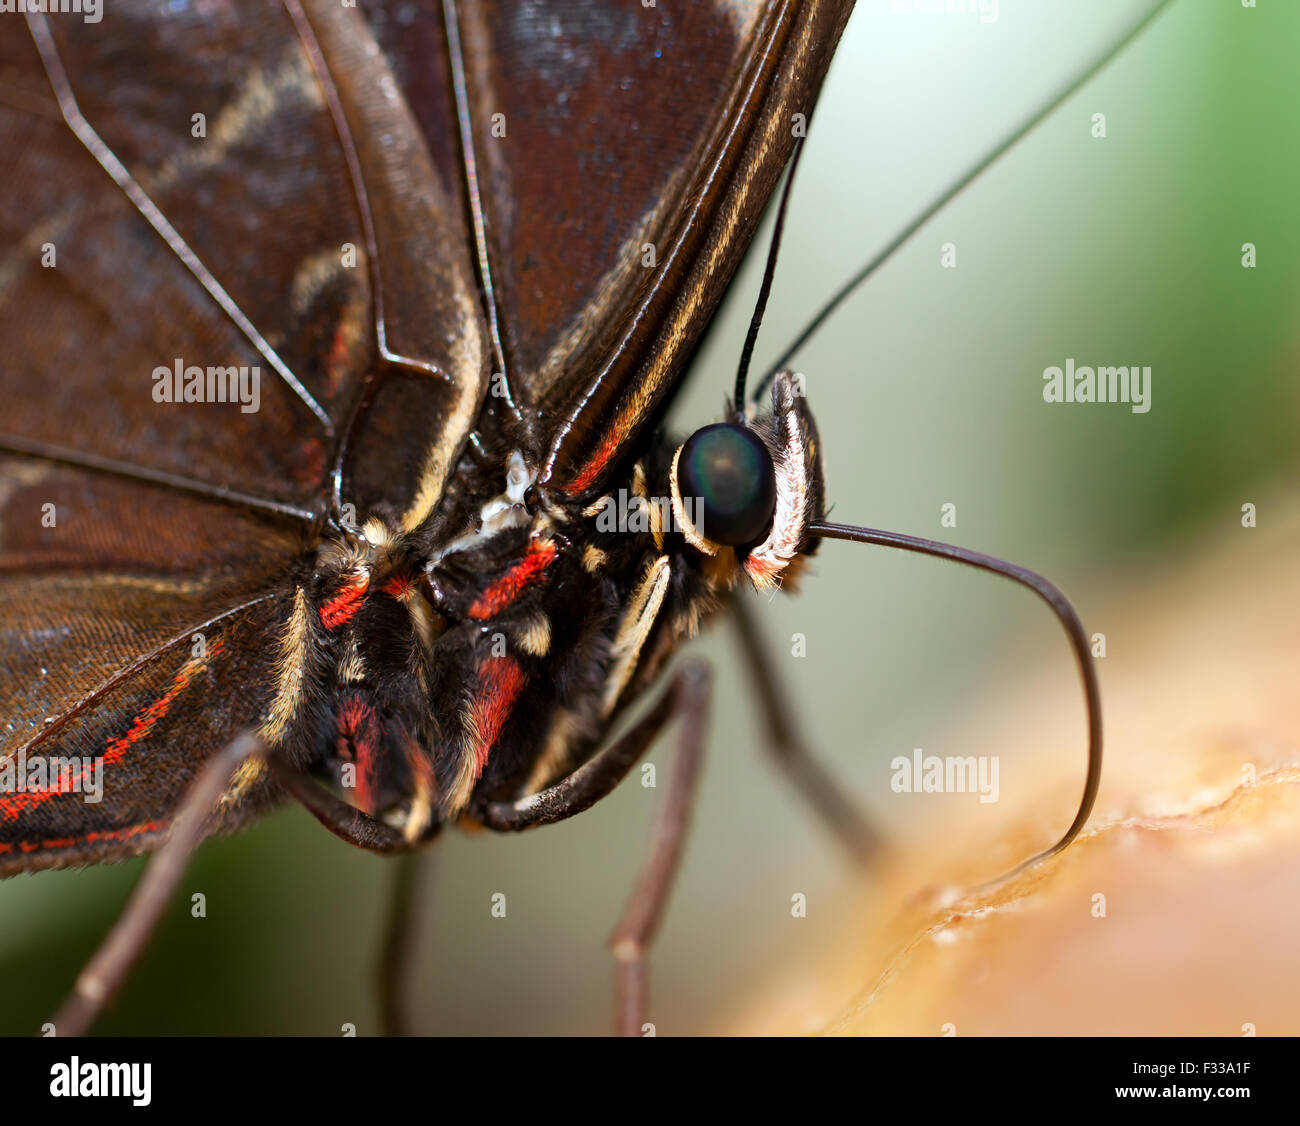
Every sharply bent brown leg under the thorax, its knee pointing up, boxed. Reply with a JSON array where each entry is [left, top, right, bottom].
[[478, 661, 711, 1036]]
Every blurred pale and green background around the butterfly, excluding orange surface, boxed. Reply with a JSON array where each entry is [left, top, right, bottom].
[[0, 0, 1300, 1035]]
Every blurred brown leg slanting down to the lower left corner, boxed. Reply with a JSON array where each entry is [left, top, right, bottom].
[[53, 732, 268, 1036]]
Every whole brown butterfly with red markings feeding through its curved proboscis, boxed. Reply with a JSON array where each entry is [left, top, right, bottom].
[[0, 0, 1149, 1032]]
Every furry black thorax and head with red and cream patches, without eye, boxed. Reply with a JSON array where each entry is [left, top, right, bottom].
[[276, 380, 822, 839]]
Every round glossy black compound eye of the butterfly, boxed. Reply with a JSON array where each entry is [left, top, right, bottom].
[[677, 423, 776, 547]]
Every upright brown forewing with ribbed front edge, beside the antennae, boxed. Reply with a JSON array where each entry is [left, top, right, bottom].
[[395, 0, 852, 493]]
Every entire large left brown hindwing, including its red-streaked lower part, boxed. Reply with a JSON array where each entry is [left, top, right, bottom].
[[0, 0, 488, 874]]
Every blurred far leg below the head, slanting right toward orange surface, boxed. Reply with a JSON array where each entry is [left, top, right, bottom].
[[732, 593, 881, 865]]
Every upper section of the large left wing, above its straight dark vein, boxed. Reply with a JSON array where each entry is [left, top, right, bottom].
[[0, 0, 488, 506]]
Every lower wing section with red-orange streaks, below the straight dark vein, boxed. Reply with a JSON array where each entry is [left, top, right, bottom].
[[0, 458, 296, 875]]
